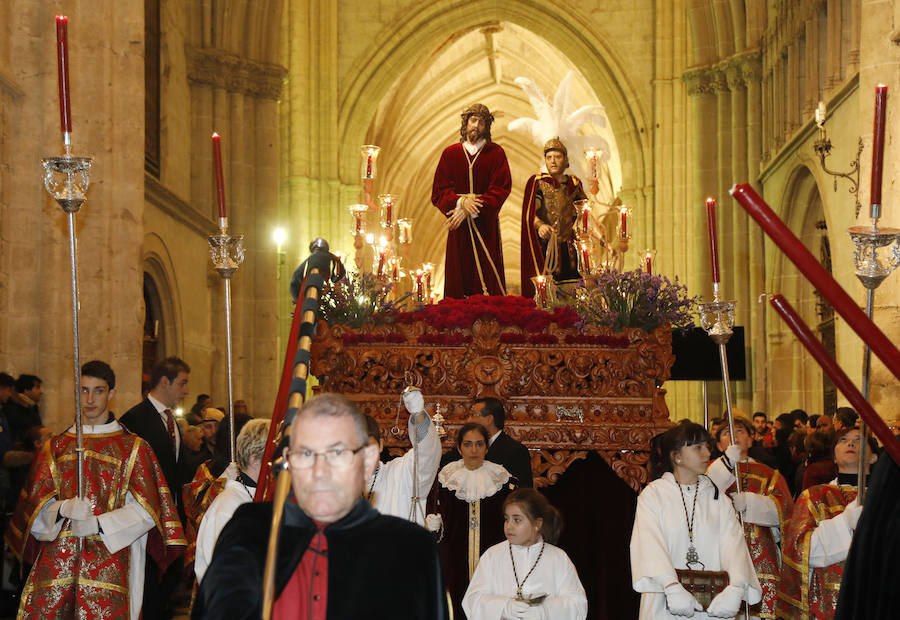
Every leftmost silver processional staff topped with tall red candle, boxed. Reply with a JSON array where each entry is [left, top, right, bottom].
[[41, 15, 93, 498]]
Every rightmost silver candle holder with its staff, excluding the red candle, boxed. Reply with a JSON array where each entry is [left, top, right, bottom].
[[847, 223, 900, 504]]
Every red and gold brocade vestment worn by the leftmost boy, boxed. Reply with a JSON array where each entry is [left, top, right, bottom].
[[6, 430, 186, 618]]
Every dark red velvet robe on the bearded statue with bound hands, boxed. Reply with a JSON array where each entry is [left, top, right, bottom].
[[431, 142, 512, 298]]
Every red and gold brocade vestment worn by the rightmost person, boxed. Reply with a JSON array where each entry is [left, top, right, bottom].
[[778, 484, 856, 620]]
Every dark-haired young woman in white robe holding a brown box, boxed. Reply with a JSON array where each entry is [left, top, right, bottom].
[[631, 420, 762, 620]]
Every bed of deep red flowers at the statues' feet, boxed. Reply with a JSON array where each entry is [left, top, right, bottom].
[[394, 295, 580, 334]]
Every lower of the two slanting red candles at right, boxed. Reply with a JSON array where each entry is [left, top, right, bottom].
[[769, 295, 900, 463]]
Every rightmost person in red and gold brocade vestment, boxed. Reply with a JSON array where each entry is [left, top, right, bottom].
[[778, 428, 877, 619]]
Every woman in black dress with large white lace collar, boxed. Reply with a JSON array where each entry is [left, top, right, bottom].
[[425, 422, 516, 618]]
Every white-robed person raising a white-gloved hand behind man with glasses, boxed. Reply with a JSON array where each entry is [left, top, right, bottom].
[[365, 387, 441, 525]]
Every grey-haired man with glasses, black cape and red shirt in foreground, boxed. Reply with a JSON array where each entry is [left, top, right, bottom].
[[193, 394, 447, 620]]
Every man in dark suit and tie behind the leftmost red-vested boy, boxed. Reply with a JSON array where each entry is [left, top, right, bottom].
[[119, 357, 191, 620]]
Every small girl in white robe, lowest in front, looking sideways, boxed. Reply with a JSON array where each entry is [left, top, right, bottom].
[[462, 489, 587, 620]]
